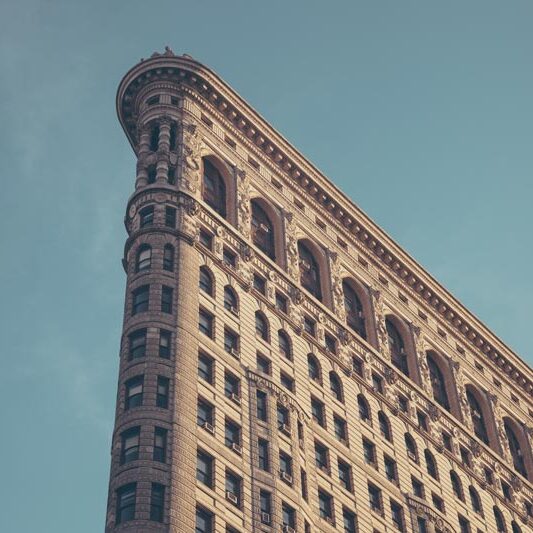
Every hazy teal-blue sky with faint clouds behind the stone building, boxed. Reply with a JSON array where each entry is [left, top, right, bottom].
[[0, 0, 533, 533]]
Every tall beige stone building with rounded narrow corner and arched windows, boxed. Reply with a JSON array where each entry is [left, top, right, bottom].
[[106, 49, 533, 533]]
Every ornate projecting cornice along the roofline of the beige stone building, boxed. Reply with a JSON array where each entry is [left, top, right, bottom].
[[117, 51, 533, 396]]
